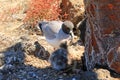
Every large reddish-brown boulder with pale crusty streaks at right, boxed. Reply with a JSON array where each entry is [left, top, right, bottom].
[[85, 0, 120, 73]]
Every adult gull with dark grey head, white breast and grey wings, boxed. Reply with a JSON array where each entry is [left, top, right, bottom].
[[39, 21, 74, 48]]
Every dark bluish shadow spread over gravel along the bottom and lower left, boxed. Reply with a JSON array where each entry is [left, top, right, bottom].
[[0, 42, 115, 80]]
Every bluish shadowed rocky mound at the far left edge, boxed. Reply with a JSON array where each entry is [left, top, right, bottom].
[[0, 43, 25, 80]]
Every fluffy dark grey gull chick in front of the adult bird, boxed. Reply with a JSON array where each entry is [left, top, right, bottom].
[[49, 44, 71, 71]]
